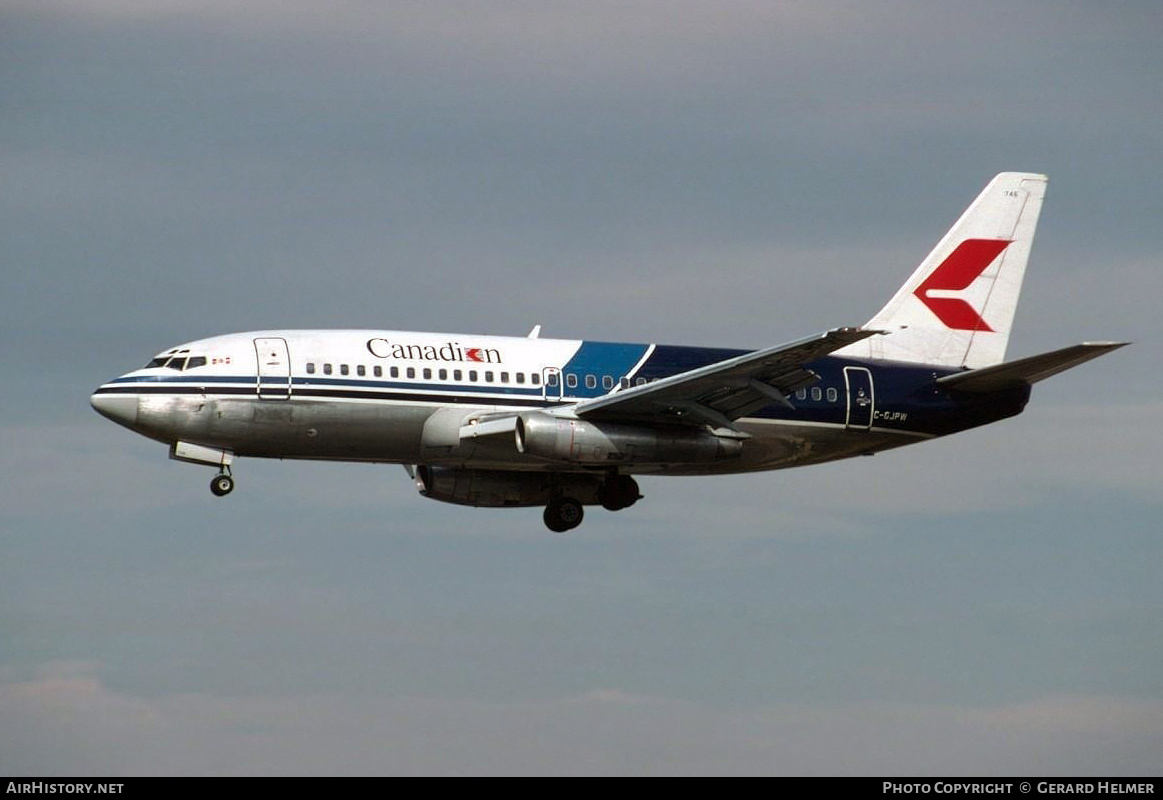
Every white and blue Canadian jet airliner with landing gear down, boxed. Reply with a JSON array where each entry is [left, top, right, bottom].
[[91, 172, 1127, 533]]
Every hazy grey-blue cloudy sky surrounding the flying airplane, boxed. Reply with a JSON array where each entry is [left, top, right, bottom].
[[0, 0, 1163, 776]]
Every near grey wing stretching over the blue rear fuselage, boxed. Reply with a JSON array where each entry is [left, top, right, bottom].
[[571, 328, 882, 428]]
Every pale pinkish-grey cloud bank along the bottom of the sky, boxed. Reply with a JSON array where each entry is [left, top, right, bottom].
[[0, 664, 1163, 777]]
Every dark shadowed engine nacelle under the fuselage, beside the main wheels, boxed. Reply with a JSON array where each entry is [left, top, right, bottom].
[[416, 466, 601, 508]]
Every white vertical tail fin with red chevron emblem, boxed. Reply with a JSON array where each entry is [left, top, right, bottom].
[[840, 172, 1046, 369]]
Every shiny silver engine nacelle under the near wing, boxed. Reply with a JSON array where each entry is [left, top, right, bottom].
[[516, 412, 743, 466]]
